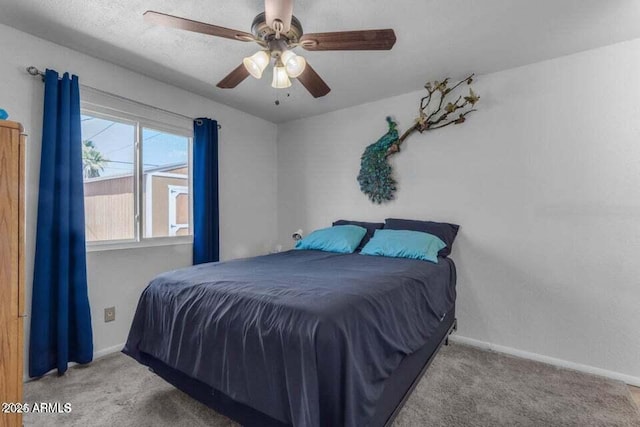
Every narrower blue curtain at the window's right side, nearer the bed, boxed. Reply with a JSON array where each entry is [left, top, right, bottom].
[[193, 118, 220, 264]]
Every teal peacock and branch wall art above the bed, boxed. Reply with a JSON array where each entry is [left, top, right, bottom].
[[358, 74, 480, 204]]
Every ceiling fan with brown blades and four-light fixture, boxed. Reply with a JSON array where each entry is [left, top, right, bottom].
[[144, 0, 396, 98]]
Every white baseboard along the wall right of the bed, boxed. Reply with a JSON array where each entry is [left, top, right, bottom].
[[450, 334, 640, 387]]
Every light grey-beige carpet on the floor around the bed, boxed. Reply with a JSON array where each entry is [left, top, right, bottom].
[[24, 344, 640, 427]]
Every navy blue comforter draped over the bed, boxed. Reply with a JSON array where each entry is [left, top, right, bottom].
[[123, 251, 455, 426]]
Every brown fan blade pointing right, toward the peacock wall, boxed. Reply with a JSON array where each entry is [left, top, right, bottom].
[[300, 29, 396, 50]]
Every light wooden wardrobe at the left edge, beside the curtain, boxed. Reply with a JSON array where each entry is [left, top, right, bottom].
[[0, 120, 25, 427]]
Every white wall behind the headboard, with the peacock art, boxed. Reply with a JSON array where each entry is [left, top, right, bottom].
[[278, 40, 640, 384]]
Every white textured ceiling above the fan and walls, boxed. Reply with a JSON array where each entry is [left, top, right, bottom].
[[0, 0, 640, 122]]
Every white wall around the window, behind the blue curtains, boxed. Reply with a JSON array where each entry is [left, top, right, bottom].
[[0, 25, 277, 374]]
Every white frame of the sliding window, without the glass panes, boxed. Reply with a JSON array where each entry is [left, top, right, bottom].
[[81, 100, 193, 252]]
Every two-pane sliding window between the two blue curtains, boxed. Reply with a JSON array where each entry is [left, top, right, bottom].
[[81, 108, 191, 244]]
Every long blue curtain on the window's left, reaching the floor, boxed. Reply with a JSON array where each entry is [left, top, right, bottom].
[[29, 70, 93, 377]]
